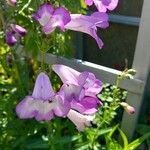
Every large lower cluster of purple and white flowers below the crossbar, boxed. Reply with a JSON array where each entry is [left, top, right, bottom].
[[16, 64, 102, 131]]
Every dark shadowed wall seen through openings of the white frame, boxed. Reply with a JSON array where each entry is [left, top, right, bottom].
[[83, 0, 143, 70]]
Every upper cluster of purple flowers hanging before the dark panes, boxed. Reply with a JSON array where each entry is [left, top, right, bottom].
[[32, 0, 118, 49]]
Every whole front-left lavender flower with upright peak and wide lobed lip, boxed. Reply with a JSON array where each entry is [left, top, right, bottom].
[[16, 73, 70, 121]]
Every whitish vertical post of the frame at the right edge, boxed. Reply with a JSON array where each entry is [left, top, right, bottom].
[[122, 0, 150, 140]]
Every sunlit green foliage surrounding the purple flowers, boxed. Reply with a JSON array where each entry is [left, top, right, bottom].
[[0, 0, 150, 150]]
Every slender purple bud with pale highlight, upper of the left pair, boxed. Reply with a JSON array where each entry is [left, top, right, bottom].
[[10, 24, 27, 36]]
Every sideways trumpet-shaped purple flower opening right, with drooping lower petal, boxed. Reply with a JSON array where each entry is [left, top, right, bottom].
[[65, 12, 109, 49]]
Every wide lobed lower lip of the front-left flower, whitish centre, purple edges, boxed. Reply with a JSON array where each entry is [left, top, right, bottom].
[[16, 95, 70, 121]]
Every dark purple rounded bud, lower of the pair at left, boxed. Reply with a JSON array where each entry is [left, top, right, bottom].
[[5, 32, 17, 46]]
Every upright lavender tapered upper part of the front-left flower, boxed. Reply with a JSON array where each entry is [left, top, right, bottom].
[[32, 72, 55, 100]]
